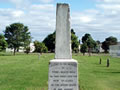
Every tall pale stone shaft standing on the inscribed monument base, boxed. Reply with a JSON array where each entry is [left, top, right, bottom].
[[55, 4, 72, 59]]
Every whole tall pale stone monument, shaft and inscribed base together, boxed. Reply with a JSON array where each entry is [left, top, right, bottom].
[[48, 4, 78, 90]]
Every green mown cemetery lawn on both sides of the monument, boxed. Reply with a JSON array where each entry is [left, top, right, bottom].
[[0, 53, 120, 90]]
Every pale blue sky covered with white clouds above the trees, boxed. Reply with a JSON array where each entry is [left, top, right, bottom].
[[0, 0, 120, 41]]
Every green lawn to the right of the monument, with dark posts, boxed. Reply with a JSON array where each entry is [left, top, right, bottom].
[[73, 55, 120, 90]]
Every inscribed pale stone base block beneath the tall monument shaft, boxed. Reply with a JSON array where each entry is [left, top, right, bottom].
[[48, 59, 78, 90]]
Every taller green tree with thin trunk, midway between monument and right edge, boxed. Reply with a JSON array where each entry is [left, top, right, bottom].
[[82, 33, 97, 56]]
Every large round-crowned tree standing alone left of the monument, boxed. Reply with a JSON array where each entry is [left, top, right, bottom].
[[4, 23, 31, 55]]
